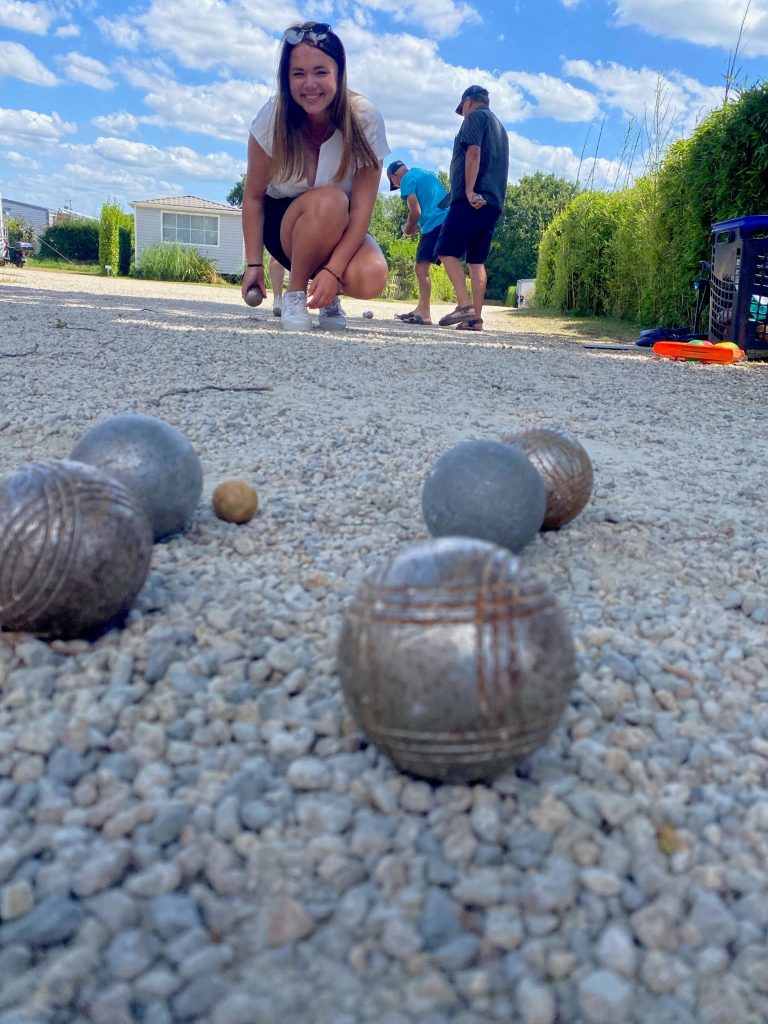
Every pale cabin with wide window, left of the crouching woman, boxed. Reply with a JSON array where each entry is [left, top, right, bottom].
[[130, 196, 245, 273]]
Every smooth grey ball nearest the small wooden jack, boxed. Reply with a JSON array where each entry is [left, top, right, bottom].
[[70, 413, 203, 541]]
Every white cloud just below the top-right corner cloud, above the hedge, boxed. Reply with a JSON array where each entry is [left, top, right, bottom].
[[563, 60, 723, 136]]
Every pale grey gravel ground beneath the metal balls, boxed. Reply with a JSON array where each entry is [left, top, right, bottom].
[[0, 268, 768, 1024]]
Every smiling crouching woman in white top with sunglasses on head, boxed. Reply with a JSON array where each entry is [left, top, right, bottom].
[[242, 22, 389, 331]]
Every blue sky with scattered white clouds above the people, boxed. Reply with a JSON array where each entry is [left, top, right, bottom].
[[0, 0, 768, 214]]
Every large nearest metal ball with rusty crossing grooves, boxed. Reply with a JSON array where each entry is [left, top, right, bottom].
[[338, 538, 577, 782]]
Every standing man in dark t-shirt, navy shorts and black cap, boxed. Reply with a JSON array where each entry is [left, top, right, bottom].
[[437, 85, 509, 331]]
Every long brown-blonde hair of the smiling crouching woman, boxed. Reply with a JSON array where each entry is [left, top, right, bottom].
[[272, 32, 379, 181]]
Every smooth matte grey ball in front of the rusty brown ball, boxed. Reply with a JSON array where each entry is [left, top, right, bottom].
[[421, 440, 547, 551]]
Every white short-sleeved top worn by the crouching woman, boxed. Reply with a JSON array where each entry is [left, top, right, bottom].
[[251, 93, 390, 199]]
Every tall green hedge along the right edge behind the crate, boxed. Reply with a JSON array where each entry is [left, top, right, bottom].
[[537, 83, 768, 327]]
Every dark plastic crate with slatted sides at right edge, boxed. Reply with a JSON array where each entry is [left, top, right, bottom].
[[710, 213, 768, 359]]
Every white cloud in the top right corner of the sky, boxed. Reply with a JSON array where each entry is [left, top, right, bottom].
[[614, 0, 768, 57]]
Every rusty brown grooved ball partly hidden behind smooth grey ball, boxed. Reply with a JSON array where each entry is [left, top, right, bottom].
[[504, 427, 594, 529]]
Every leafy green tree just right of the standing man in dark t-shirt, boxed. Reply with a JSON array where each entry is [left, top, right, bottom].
[[486, 171, 578, 299]]
